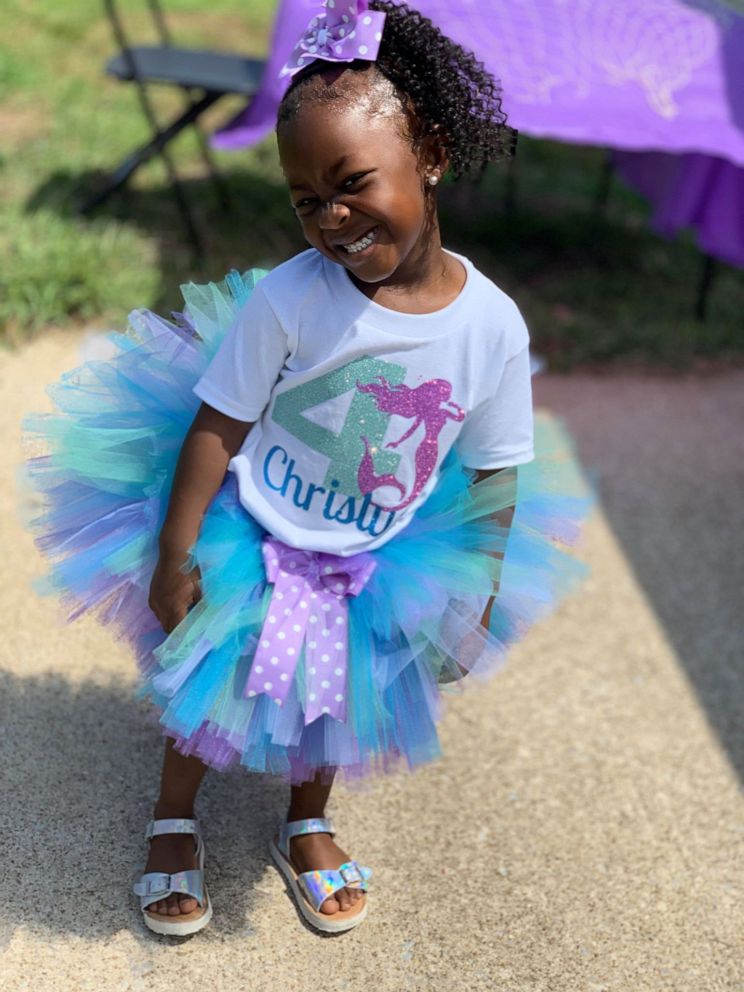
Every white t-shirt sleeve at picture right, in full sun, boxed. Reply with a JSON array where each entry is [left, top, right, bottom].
[[455, 344, 535, 469]]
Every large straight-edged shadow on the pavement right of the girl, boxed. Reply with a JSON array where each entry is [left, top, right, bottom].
[[535, 370, 744, 781]]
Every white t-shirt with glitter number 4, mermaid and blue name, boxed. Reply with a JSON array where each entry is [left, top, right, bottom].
[[194, 249, 533, 555]]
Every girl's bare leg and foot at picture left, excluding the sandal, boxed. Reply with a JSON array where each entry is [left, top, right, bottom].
[[145, 737, 207, 916]]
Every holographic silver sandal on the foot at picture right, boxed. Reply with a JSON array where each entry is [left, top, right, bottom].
[[270, 817, 372, 933]]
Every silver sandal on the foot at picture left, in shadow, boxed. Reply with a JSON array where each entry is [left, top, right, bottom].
[[133, 819, 212, 937]]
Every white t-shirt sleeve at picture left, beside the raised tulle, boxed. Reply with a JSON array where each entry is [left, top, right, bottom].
[[194, 285, 289, 421]]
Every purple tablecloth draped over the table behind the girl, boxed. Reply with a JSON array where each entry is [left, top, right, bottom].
[[212, 0, 744, 265]]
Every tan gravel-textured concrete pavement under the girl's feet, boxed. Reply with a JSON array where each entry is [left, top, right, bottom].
[[0, 331, 744, 992]]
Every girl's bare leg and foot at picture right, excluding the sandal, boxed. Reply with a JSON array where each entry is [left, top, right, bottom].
[[287, 776, 362, 914]]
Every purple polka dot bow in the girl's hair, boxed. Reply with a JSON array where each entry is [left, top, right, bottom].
[[279, 0, 385, 76]]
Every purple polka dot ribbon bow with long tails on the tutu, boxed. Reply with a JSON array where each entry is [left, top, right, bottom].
[[244, 537, 375, 724]]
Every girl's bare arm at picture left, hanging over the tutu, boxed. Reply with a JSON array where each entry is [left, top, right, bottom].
[[149, 403, 253, 634]]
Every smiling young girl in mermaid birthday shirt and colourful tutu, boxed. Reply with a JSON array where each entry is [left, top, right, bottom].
[[23, 0, 581, 935]]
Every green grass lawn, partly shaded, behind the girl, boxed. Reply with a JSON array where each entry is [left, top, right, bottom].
[[0, 0, 744, 369]]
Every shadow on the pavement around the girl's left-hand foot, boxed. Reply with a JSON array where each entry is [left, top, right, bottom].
[[0, 673, 287, 946]]
